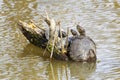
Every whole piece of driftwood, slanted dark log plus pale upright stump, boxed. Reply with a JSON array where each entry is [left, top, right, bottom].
[[18, 15, 68, 60]]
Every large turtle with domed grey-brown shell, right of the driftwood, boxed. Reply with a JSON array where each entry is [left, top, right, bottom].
[[69, 25, 96, 62]]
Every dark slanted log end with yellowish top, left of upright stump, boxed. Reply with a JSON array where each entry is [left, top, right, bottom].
[[18, 21, 48, 47]]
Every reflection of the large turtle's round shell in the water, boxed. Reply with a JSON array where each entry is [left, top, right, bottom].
[[70, 63, 96, 80]]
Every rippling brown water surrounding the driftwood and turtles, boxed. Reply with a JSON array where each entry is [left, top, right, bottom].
[[0, 0, 120, 80]]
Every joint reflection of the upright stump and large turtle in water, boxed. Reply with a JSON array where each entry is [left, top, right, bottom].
[[48, 61, 96, 80]]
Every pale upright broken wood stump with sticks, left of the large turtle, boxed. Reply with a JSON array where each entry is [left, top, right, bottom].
[[44, 13, 68, 60]]
